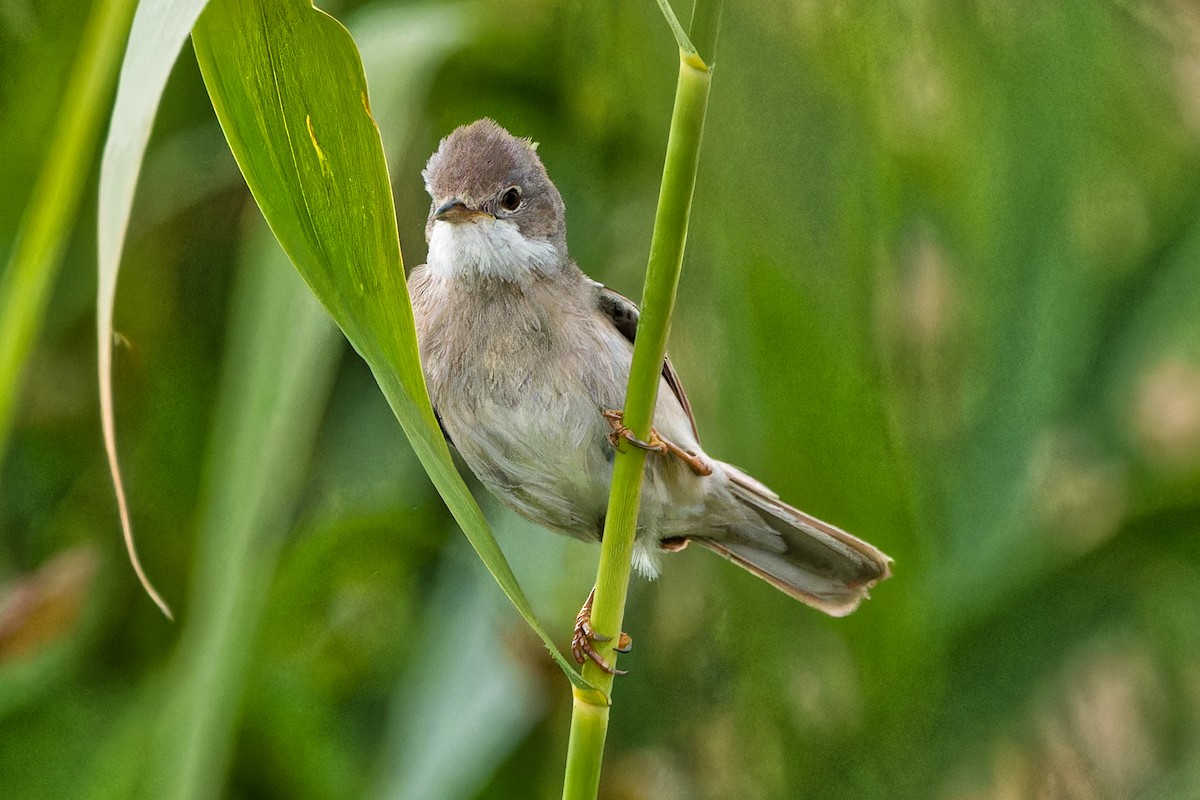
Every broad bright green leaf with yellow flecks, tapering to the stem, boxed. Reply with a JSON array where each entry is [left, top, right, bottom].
[[193, 0, 587, 687]]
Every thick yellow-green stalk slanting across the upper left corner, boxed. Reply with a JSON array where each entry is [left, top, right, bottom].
[[0, 0, 137, 456]]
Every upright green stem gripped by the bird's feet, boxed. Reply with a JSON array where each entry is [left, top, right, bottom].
[[563, 0, 720, 800]]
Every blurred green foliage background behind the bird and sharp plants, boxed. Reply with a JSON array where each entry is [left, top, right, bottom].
[[0, 0, 1200, 800]]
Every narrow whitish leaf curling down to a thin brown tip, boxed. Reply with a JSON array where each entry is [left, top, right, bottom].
[[96, 0, 208, 616]]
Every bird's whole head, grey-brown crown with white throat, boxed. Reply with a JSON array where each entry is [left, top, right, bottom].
[[421, 119, 568, 282]]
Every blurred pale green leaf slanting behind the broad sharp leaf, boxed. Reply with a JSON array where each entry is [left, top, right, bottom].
[[139, 7, 468, 798]]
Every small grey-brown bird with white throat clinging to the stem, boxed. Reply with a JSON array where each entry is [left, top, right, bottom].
[[408, 119, 892, 673]]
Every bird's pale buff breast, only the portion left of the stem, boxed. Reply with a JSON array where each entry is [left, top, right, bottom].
[[410, 271, 628, 539]]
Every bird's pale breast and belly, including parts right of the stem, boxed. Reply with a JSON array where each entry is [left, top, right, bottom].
[[410, 267, 704, 540]]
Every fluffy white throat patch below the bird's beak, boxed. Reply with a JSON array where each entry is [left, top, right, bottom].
[[428, 217, 560, 283]]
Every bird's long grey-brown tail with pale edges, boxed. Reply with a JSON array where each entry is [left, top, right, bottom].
[[695, 464, 892, 616]]
